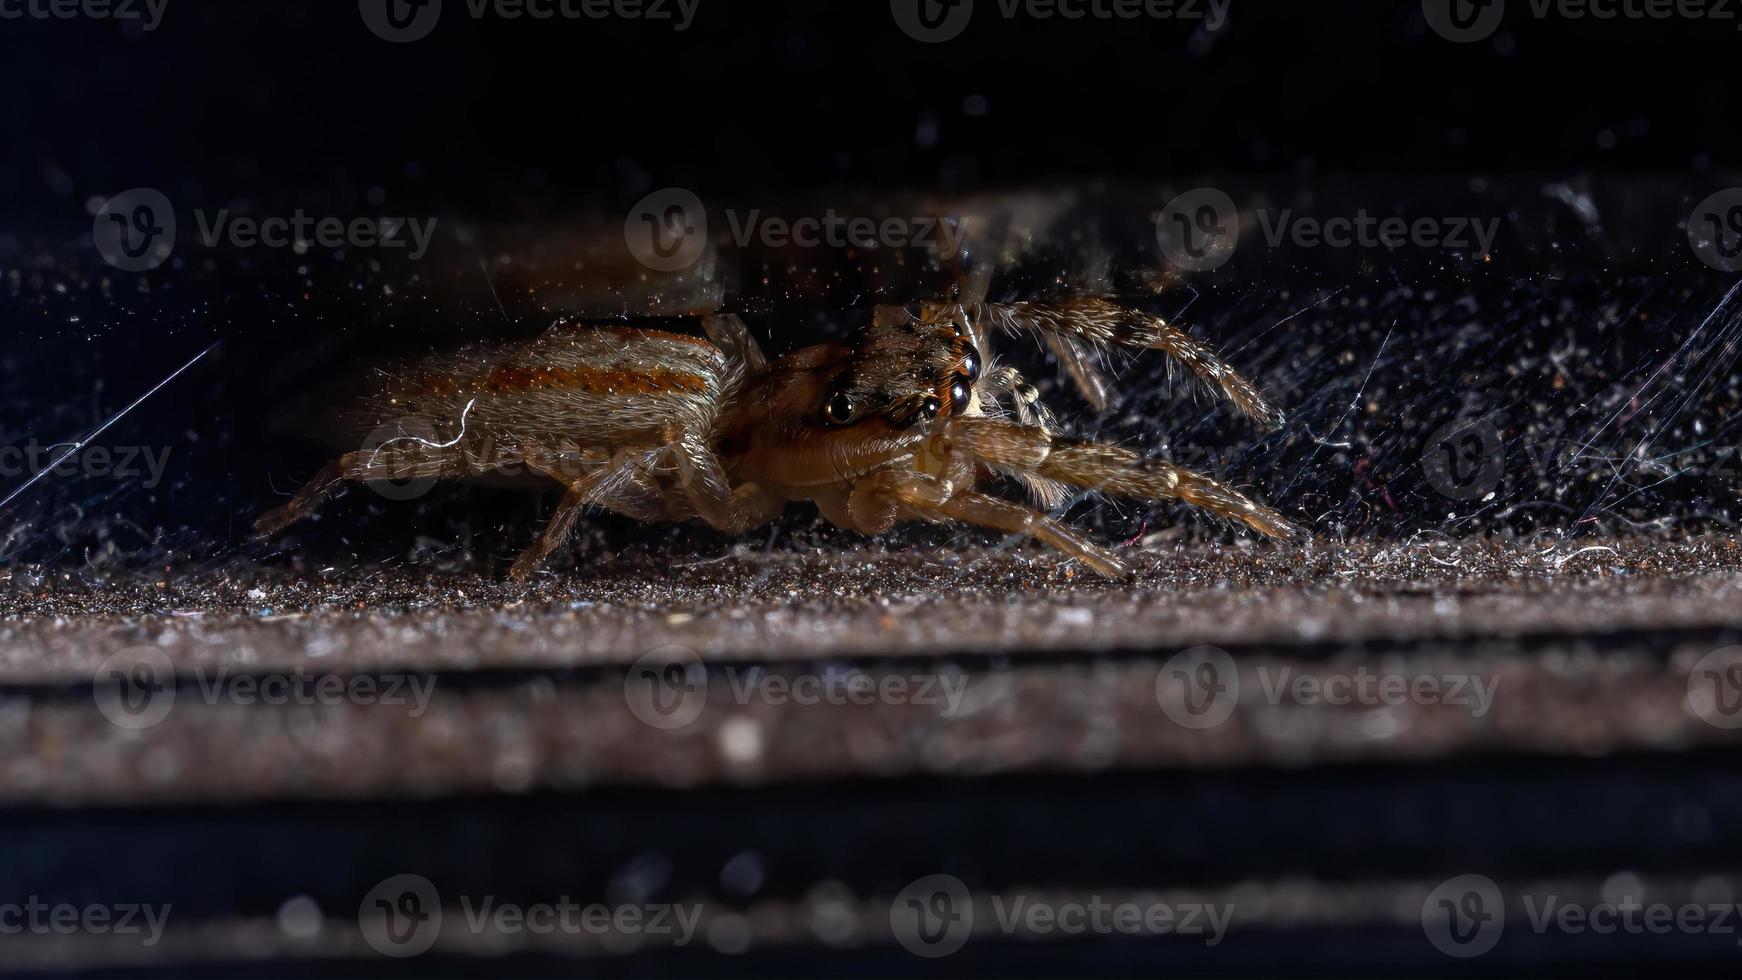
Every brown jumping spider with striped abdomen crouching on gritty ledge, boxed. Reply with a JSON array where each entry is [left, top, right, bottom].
[[256, 299, 1296, 578]]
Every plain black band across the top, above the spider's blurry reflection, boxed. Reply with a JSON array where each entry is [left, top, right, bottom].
[[0, 0, 1742, 205]]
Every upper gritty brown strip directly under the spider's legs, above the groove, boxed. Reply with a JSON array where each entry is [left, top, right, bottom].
[[10, 538, 1742, 682]]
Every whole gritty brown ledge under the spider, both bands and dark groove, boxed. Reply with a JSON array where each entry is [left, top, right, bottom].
[[0, 538, 1742, 802]]
